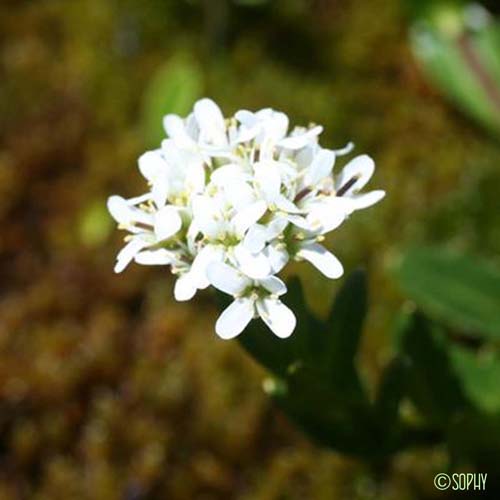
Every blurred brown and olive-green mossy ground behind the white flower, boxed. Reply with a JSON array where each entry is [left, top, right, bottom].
[[0, 0, 500, 500]]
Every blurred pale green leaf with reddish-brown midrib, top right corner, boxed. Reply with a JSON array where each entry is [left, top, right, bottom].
[[411, 2, 500, 136]]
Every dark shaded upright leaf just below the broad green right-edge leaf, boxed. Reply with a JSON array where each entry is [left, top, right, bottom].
[[400, 312, 468, 428]]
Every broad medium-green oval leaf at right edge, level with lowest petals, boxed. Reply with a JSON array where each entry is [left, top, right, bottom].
[[395, 248, 500, 339]]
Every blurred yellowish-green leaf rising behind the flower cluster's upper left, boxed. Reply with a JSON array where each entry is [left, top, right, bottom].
[[142, 56, 203, 146]]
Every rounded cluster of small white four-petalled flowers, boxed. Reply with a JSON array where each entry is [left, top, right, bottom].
[[108, 99, 385, 339]]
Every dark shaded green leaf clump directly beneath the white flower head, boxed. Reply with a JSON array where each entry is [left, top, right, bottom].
[[232, 271, 432, 462]]
